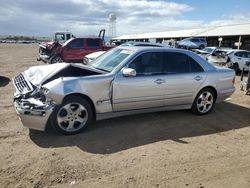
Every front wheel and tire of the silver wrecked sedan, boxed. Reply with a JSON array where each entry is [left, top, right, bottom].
[[51, 95, 93, 135]]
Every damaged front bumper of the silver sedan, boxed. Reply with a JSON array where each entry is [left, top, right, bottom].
[[14, 98, 55, 131]]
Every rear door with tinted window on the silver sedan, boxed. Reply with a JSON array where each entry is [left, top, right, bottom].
[[163, 52, 206, 106]]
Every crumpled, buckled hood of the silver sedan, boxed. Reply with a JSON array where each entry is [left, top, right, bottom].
[[24, 63, 105, 86]]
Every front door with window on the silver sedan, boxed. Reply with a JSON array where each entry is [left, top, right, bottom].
[[112, 52, 166, 111]]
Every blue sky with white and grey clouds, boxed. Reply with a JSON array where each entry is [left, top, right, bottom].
[[0, 0, 250, 36]]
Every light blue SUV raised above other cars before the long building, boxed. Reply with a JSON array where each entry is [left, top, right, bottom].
[[177, 38, 207, 49]]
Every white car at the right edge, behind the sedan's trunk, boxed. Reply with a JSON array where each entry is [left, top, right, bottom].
[[227, 50, 250, 72]]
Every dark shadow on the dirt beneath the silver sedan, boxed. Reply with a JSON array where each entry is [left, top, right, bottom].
[[30, 102, 250, 154]]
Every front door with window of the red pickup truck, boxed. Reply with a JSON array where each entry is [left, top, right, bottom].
[[63, 38, 84, 62]]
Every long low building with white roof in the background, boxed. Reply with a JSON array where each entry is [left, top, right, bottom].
[[113, 23, 250, 50]]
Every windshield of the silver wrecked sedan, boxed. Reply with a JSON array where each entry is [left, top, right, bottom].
[[90, 48, 133, 72]]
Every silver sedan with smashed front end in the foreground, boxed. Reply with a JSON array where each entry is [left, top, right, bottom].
[[13, 47, 235, 134]]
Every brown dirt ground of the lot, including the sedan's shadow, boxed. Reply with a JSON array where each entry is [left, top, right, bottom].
[[0, 44, 250, 188]]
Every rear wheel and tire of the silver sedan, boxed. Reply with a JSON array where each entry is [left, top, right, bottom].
[[191, 88, 215, 115]]
